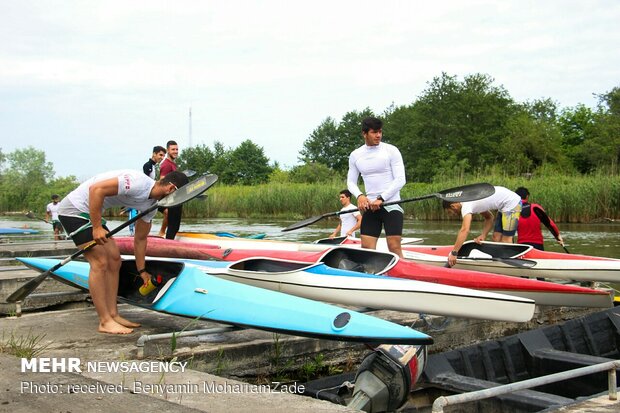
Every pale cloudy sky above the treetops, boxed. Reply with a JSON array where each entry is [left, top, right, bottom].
[[0, 0, 620, 180]]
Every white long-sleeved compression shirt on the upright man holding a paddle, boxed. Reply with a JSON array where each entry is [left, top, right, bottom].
[[347, 142, 406, 202]]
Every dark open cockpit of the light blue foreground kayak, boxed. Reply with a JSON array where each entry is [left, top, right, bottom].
[[118, 260, 185, 306]]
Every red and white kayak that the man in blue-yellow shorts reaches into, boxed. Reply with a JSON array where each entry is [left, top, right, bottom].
[[403, 241, 620, 283]]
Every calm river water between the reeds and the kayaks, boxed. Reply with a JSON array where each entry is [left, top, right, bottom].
[[0, 214, 620, 258]]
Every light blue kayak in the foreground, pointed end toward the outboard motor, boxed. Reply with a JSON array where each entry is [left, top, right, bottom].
[[18, 258, 433, 344]]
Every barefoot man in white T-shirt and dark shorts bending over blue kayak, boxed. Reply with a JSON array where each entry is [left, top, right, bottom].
[[58, 170, 189, 334]]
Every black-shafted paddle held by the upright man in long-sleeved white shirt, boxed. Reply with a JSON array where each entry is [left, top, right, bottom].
[[282, 183, 495, 232]]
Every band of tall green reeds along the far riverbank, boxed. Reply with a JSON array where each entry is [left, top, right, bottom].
[[177, 173, 620, 222]]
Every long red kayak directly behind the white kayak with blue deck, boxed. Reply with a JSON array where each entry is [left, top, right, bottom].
[[115, 237, 612, 308]]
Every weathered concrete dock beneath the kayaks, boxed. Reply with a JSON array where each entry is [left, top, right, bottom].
[[0, 240, 620, 413]]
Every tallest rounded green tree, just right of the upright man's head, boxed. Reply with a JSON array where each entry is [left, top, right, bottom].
[[386, 73, 515, 182]]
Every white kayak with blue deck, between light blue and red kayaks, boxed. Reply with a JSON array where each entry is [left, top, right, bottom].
[[167, 257, 535, 322]]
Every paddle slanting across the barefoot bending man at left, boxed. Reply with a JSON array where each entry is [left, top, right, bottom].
[[6, 175, 217, 303]]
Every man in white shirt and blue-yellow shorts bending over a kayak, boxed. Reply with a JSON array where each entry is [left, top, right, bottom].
[[443, 186, 521, 267]]
